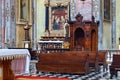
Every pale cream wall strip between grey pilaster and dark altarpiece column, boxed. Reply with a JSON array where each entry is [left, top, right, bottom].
[[36, 0, 45, 41]]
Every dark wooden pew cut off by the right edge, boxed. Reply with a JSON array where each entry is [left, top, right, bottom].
[[110, 54, 120, 78]]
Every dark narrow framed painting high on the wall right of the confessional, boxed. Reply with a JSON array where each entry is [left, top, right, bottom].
[[104, 0, 111, 21]]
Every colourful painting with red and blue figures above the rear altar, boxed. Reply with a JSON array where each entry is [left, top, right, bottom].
[[51, 6, 68, 30]]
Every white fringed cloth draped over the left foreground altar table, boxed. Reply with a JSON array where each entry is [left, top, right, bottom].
[[0, 49, 31, 73]]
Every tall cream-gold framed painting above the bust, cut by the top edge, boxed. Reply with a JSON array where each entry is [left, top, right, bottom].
[[17, 0, 32, 24]]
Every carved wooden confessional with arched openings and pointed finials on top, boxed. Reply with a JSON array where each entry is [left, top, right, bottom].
[[70, 14, 98, 51]]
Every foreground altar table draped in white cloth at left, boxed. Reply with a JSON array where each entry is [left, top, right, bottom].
[[0, 49, 31, 80]]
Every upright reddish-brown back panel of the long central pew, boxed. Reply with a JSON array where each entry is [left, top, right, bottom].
[[39, 51, 88, 64]]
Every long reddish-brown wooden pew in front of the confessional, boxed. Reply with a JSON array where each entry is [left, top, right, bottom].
[[36, 51, 89, 74]]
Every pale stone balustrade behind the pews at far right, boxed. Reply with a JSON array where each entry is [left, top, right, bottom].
[[99, 49, 120, 63]]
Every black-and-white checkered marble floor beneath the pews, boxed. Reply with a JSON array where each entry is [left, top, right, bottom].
[[20, 71, 120, 80]]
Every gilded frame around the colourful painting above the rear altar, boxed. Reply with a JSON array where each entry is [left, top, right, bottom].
[[49, 2, 70, 36]]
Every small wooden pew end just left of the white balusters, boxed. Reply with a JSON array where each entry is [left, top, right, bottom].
[[98, 51, 108, 71]]
